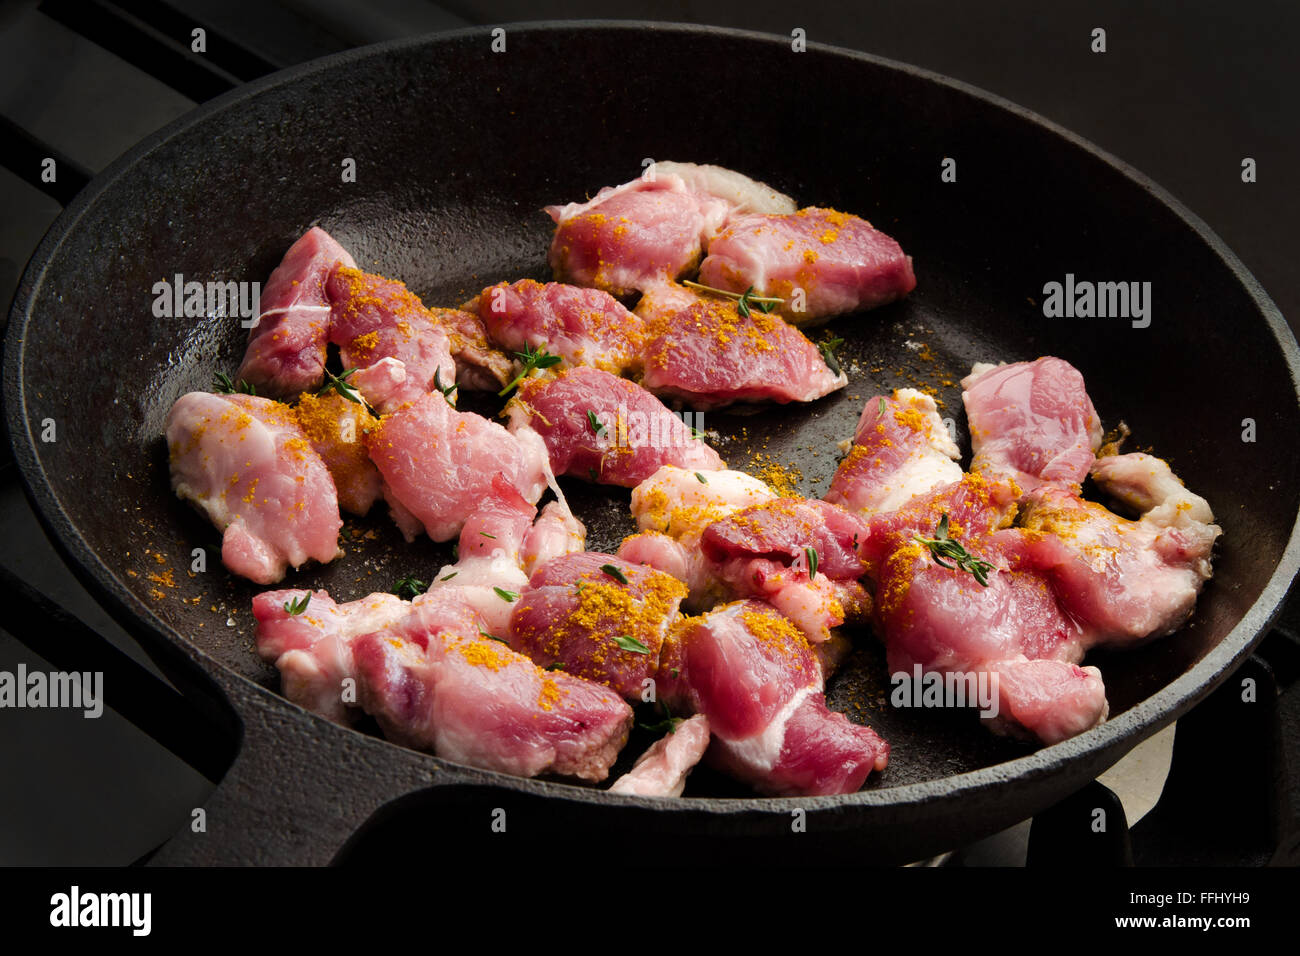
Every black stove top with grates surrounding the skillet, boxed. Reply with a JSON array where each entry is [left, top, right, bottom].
[[0, 0, 1300, 866]]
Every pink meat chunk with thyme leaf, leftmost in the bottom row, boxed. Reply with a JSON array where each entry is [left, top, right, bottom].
[[252, 589, 410, 724]]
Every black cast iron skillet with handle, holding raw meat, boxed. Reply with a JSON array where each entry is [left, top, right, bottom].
[[4, 22, 1300, 862]]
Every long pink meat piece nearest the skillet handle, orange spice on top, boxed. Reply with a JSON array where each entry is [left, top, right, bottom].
[[354, 593, 632, 782]]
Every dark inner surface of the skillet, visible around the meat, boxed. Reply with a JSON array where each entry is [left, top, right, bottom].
[[10, 27, 1300, 795]]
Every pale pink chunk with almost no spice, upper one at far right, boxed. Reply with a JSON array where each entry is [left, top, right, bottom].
[[962, 356, 1101, 492]]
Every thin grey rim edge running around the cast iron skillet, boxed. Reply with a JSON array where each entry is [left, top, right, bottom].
[[4, 20, 1300, 814]]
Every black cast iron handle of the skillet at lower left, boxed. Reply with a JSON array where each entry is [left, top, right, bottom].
[[142, 667, 460, 866]]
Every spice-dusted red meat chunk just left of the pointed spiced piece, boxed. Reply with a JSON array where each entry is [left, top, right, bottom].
[[467, 278, 642, 381]]
